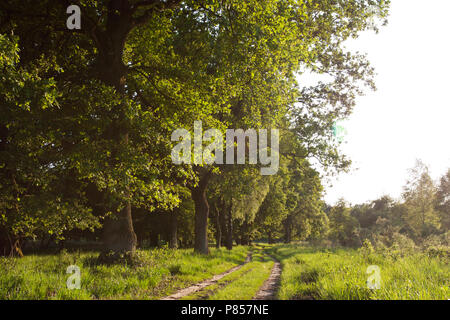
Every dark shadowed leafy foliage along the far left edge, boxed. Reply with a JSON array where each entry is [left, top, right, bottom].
[[0, 34, 100, 255]]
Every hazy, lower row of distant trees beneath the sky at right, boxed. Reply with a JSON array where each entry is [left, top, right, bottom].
[[326, 161, 450, 247]]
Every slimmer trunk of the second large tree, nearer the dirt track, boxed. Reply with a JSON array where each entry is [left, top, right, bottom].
[[191, 172, 210, 254]]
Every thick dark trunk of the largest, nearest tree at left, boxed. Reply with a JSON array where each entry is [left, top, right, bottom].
[[90, 0, 156, 258]]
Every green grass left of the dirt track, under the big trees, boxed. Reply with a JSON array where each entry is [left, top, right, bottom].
[[0, 246, 248, 300]]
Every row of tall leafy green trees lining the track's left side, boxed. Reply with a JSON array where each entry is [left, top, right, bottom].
[[0, 0, 389, 256]]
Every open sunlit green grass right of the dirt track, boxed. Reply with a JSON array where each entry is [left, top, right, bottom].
[[271, 245, 450, 300]]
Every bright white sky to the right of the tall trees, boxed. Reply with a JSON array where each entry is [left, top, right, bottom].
[[325, 0, 450, 204]]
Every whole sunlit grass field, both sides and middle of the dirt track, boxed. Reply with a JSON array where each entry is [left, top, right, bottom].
[[0, 244, 450, 300]]
